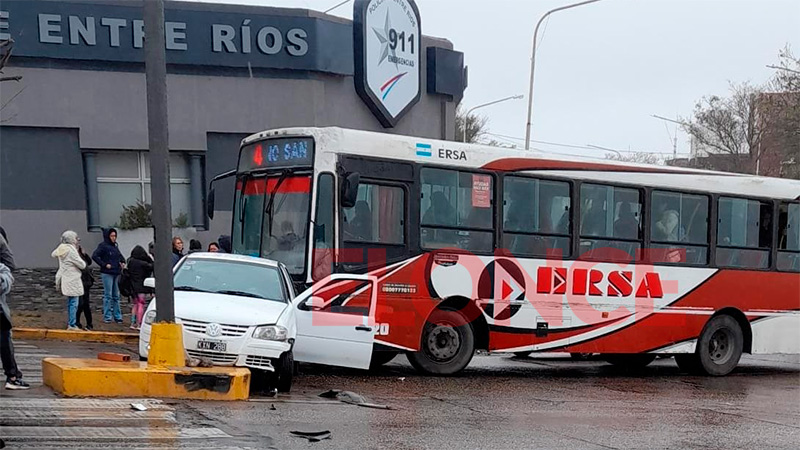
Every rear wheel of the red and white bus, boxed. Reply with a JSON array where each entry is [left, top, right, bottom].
[[696, 314, 744, 377]]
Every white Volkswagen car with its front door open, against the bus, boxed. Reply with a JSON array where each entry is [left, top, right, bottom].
[[139, 253, 378, 392]]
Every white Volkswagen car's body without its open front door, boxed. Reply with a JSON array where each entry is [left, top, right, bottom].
[[139, 253, 297, 391]]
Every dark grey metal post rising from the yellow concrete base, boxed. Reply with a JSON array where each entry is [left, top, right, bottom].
[[144, 0, 175, 322]]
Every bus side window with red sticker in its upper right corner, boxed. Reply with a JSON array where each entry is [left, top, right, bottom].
[[420, 168, 494, 253]]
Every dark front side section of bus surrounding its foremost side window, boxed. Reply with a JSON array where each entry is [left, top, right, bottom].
[[339, 156, 415, 273]]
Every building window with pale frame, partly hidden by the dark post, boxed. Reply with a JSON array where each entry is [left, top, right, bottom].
[[89, 151, 191, 227]]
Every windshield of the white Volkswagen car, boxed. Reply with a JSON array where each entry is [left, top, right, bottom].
[[174, 258, 286, 303]]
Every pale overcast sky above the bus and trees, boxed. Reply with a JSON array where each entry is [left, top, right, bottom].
[[178, 0, 800, 157]]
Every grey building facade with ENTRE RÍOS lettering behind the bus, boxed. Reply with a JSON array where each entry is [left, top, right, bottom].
[[0, 0, 466, 268]]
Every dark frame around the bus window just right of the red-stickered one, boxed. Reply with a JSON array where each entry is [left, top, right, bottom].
[[495, 172, 579, 261]]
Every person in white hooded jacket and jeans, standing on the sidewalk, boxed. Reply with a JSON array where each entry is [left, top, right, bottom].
[[50, 230, 86, 330]]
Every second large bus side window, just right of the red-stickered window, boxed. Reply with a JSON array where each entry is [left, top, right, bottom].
[[503, 177, 572, 258]]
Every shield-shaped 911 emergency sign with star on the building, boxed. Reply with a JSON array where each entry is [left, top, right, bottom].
[[353, 0, 422, 128]]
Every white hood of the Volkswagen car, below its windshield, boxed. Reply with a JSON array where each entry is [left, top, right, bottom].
[[168, 291, 288, 326]]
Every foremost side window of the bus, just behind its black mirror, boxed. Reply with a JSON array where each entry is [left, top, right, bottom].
[[342, 183, 405, 245]]
